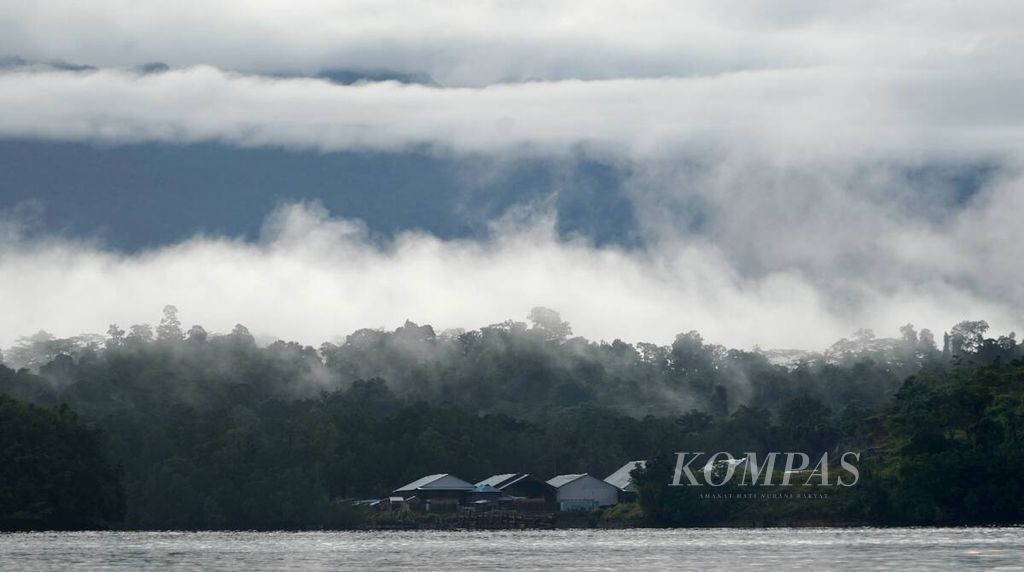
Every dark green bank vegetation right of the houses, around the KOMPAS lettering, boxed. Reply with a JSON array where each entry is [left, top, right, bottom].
[[635, 357, 1024, 526]]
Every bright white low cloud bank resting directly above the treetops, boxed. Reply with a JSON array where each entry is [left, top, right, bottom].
[[0, 205, 1021, 349]]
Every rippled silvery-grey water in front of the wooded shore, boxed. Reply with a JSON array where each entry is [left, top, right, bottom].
[[0, 528, 1024, 572]]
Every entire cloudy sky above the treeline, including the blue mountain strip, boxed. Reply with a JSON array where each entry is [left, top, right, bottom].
[[0, 0, 1024, 350]]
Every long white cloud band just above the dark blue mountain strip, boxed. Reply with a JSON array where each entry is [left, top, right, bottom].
[[0, 68, 1024, 164]]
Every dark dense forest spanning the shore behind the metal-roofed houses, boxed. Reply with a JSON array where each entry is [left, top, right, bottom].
[[0, 306, 1024, 528]]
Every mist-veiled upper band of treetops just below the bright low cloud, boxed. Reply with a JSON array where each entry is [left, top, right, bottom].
[[3, 306, 999, 416]]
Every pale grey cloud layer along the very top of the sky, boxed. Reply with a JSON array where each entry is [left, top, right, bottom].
[[0, 0, 1024, 85]]
